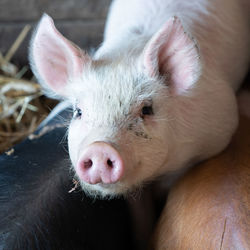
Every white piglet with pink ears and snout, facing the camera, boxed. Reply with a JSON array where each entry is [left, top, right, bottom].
[[30, 0, 250, 197]]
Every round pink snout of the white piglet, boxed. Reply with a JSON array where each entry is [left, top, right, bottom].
[[76, 142, 124, 184]]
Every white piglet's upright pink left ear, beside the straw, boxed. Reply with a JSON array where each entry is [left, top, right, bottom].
[[30, 14, 90, 96]]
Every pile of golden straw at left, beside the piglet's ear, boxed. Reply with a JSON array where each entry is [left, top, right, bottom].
[[0, 25, 55, 153]]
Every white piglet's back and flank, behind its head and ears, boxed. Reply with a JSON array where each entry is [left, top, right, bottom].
[[97, 0, 250, 90]]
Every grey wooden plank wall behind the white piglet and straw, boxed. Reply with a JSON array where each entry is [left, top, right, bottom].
[[0, 0, 111, 65]]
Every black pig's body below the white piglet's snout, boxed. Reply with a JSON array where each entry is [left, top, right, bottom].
[[0, 108, 138, 250]]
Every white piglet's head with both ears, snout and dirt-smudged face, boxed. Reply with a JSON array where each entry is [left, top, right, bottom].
[[30, 15, 200, 196]]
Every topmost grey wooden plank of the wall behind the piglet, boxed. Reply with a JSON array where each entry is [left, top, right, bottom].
[[0, 0, 111, 22]]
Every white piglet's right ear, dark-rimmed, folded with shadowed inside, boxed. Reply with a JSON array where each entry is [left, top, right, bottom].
[[143, 17, 201, 94]]
